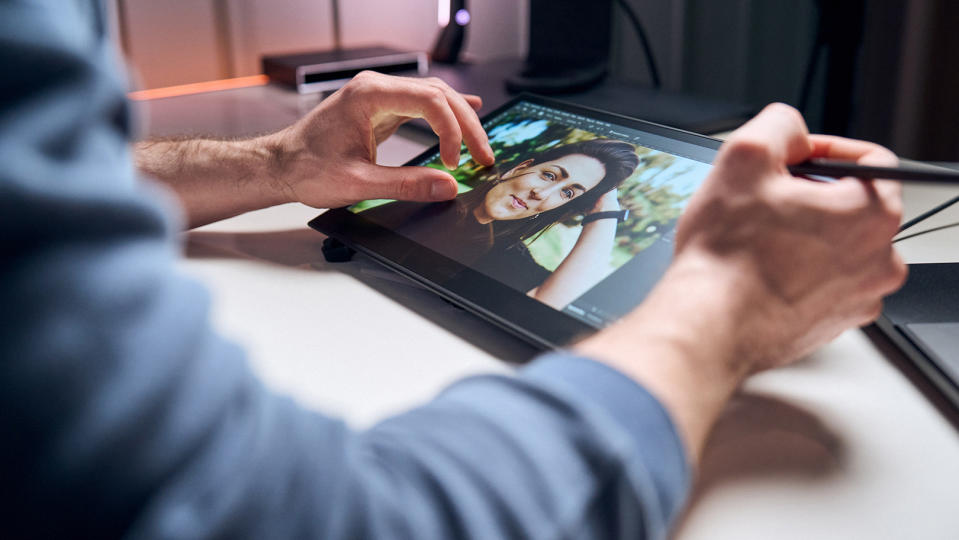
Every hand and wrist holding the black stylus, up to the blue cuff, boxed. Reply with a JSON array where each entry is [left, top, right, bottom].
[[577, 104, 906, 461]]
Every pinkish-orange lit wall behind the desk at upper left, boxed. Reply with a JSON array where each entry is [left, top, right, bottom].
[[118, 0, 528, 88]]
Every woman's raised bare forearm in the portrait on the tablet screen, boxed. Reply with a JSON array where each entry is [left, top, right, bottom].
[[533, 219, 616, 309]]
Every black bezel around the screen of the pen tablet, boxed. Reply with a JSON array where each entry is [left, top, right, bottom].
[[309, 94, 722, 348]]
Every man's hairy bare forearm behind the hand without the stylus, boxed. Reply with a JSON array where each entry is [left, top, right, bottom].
[[135, 136, 294, 228]]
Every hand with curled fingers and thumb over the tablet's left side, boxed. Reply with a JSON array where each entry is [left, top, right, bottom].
[[271, 72, 494, 208]]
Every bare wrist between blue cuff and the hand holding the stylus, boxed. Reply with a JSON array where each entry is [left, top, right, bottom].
[[575, 251, 749, 463]]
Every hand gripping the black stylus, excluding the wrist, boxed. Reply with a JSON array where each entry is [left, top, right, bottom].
[[676, 105, 906, 372]]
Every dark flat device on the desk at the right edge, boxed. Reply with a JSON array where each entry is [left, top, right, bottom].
[[876, 263, 959, 410]]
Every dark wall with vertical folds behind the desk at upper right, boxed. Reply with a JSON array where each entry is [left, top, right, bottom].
[[612, 0, 959, 162]]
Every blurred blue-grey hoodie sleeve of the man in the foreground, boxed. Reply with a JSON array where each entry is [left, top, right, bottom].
[[0, 0, 689, 538]]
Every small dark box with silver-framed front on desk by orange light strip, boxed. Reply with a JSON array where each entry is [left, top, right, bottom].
[[261, 47, 429, 93]]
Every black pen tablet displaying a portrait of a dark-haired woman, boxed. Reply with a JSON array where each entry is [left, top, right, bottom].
[[310, 96, 720, 347]]
